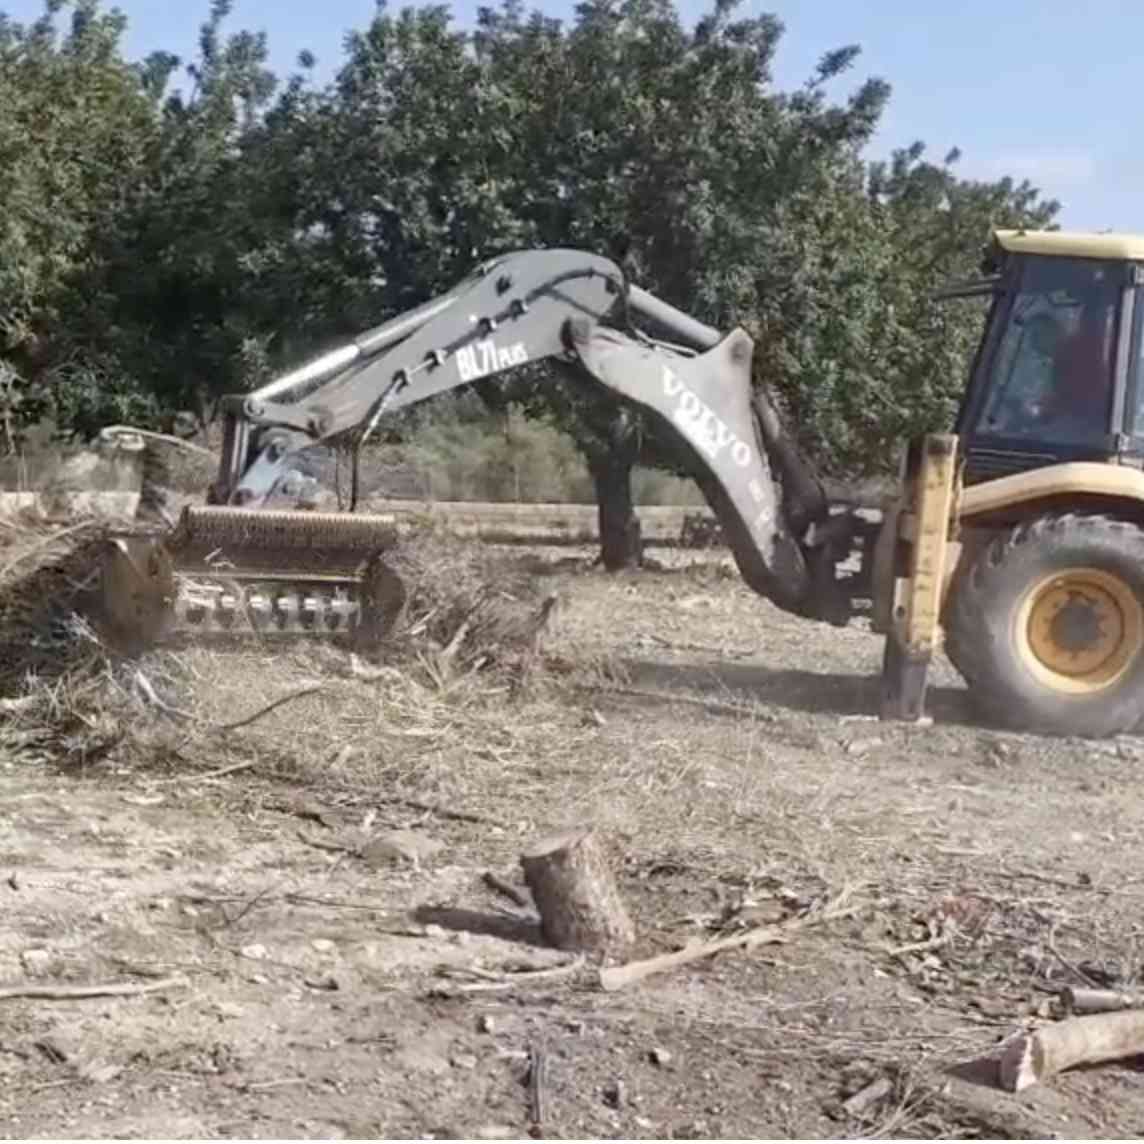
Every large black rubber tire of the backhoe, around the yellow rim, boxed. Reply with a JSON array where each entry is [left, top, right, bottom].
[[945, 514, 1144, 738]]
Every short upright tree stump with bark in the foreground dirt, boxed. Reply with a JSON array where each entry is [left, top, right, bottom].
[[521, 827, 636, 956]]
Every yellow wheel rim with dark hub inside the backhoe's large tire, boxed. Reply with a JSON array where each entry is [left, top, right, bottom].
[[1015, 569, 1144, 694]]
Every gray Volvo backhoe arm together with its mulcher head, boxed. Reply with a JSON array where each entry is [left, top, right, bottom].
[[108, 249, 850, 649]]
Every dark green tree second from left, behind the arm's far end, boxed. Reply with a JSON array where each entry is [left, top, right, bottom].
[[70, 0, 284, 421]]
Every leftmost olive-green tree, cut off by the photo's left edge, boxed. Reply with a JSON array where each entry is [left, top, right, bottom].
[[0, 0, 163, 444]]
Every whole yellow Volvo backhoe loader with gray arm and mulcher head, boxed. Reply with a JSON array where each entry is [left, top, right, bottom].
[[102, 230, 1144, 737]]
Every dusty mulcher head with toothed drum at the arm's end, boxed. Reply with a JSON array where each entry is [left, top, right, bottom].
[[102, 506, 405, 643]]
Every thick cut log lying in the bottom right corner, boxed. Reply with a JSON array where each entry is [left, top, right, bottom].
[[1001, 1010, 1144, 1093]]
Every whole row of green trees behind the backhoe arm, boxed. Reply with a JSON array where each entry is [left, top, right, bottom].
[[0, 0, 1057, 563]]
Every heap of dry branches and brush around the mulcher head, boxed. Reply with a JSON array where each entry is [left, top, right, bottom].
[[0, 518, 555, 782]]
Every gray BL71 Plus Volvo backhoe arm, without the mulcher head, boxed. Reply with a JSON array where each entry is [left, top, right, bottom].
[[212, 249, 844, 622]]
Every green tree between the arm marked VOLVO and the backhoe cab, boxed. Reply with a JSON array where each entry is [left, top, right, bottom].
[[748, 144, 1058, 477]]
